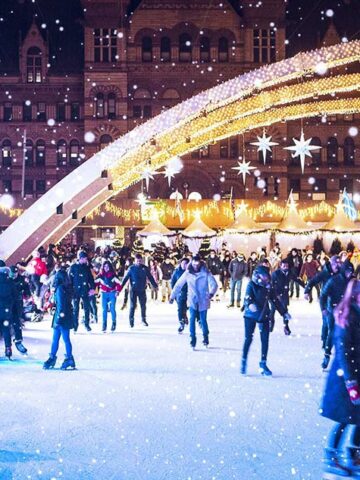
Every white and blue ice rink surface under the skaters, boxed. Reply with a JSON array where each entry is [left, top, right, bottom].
[[0, 300, 331, 480]]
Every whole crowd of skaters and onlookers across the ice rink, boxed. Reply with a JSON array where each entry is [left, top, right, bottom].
[[0, 235, 360, 475]]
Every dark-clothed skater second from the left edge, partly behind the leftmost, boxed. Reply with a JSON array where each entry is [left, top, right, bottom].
[[9, 265, 30, 355]]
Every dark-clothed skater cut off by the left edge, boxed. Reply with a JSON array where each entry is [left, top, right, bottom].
[[0, 260, 17, 360]]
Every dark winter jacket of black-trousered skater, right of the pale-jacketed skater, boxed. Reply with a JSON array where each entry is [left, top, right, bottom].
[[244, 280, 287, 323]]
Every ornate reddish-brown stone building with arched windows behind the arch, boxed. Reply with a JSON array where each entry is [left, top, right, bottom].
[[0, 0, 360, 232]]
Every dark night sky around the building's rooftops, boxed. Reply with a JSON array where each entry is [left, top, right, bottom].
[[0, 0, 360, 73]]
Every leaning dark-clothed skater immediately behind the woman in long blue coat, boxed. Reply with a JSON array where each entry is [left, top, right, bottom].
[[320, 260, 354, 370]]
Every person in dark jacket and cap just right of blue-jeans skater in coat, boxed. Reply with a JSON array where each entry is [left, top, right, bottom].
[[69, 250, 95, 332]]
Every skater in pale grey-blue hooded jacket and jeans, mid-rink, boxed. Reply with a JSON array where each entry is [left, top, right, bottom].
[[170, 255, 217, 349]]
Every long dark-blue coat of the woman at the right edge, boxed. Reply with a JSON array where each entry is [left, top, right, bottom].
[[321, 305, 360, 426]]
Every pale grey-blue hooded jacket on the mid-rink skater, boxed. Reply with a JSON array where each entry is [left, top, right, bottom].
[[170, 265, 217, 312]]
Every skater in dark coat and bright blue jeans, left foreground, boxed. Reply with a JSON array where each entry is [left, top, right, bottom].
[[43, 268, 75, 370]]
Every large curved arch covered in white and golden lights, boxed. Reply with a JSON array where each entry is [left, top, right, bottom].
[[0, 41, 360, 262]]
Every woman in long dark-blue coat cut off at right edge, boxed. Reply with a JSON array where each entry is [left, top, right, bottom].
[[320, 280, 360, 478]]
